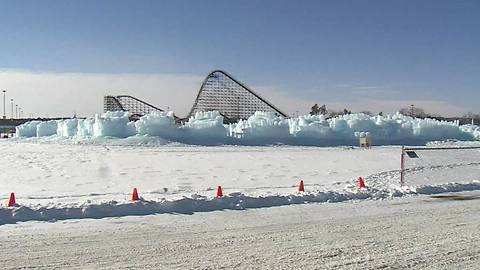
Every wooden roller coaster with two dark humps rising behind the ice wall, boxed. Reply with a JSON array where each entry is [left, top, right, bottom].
[[103, 70, 287, 123]]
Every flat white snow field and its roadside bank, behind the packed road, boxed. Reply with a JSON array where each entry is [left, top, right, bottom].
[[0, 140, 480, 224]]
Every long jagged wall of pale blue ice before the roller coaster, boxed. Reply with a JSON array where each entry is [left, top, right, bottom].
[[16, 112, 480, 146]]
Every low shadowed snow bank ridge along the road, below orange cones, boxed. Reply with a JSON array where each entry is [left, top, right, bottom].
[[0, 181, 480, 225]]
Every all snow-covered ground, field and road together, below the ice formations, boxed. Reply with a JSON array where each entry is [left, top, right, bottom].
[[0, 138, 480, 269]]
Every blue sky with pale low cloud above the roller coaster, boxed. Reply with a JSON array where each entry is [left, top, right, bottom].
[[0, 0, 480, 115]]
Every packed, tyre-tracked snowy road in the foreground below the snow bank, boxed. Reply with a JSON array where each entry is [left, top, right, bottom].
[[0, 192, 480, 269]]
